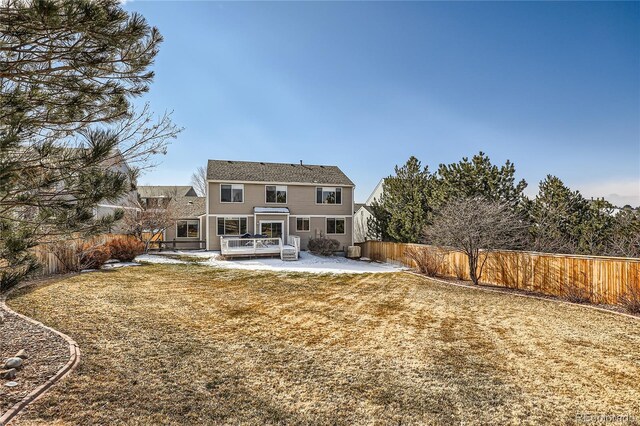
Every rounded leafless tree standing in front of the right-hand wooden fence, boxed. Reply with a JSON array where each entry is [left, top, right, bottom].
[[424, 197, 527, 284]]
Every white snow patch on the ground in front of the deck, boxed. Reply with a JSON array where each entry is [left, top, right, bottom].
[[136, 251, 405, 274]]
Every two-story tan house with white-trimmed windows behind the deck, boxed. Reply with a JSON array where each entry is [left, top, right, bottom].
[[206, 160, 355, 250]]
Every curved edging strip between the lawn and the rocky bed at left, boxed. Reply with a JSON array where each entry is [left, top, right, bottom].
[[0, 288, 80, 426]]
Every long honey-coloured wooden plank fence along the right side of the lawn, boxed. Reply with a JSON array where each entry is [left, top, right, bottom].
[[359, 241, 640, 303]]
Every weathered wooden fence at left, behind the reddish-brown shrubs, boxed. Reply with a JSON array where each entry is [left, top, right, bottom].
[[33, 234, 135, 276]]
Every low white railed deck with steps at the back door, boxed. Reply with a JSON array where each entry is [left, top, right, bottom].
[[220, 236, 300, 260]]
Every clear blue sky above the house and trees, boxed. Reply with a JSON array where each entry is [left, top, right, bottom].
[[125, 1, 640, 205]]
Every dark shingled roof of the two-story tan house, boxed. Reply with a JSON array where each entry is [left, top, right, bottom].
[[207, 160, 354, 186]]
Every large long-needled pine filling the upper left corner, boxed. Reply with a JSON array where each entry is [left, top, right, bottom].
[[0, 0, 178, 290]]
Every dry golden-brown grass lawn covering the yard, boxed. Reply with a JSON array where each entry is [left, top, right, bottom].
[[9, 265, 640, 425]]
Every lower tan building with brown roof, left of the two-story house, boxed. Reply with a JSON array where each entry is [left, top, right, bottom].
[[138, 186, 206, 249]]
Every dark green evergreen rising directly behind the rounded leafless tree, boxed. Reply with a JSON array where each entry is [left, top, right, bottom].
[[436, 152, 527, 208]]
